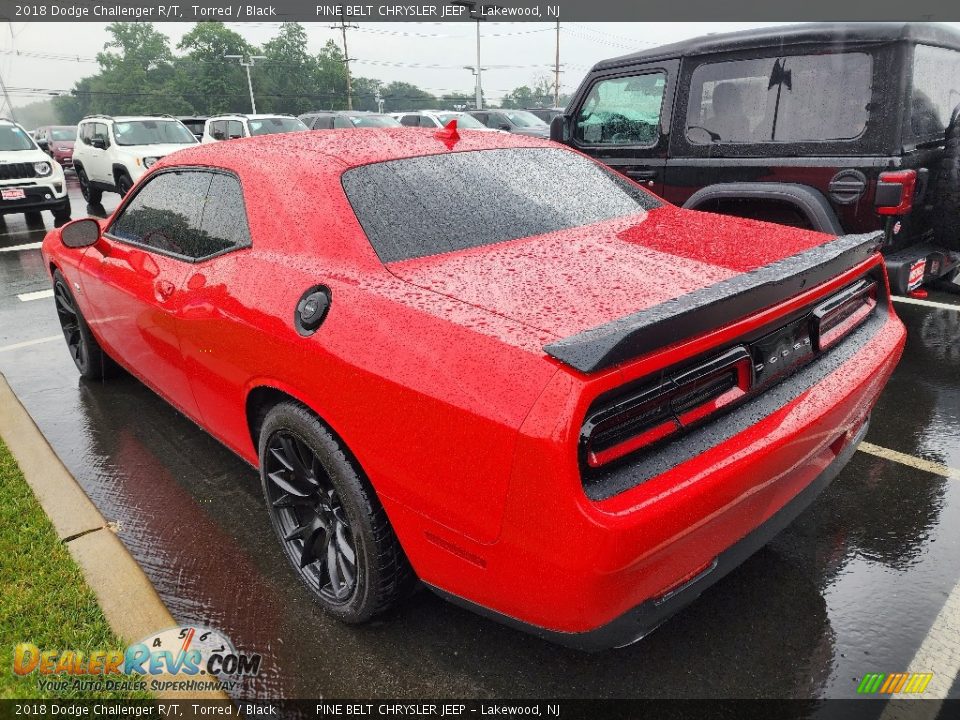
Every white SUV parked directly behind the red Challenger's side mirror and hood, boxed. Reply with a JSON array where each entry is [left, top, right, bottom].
[[73, 115, 197, 205]]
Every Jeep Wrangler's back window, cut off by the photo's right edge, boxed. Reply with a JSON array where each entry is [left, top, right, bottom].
[[910, 45, 960, 139]]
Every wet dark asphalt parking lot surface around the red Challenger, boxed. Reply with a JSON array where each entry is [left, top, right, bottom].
[[0, 179, 960, 698]]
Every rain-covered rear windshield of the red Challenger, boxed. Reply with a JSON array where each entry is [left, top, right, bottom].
[[342, 148, 659, 262]]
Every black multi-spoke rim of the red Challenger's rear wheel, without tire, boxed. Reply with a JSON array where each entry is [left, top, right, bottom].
[[265, 430, 357, 605]]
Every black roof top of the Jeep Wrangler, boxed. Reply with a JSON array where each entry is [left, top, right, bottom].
[[593, 22, 960, 70]]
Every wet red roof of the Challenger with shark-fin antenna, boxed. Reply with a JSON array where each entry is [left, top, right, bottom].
[[158, 127, 560, 169]]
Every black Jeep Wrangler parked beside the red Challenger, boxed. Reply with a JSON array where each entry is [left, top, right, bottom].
[[551, 23, 960, 294]]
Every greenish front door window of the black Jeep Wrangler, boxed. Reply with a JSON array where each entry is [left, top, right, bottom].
[[574, 70, 667, 147]]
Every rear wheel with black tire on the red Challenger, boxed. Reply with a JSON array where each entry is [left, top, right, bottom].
[[259, 402, 413, 623]]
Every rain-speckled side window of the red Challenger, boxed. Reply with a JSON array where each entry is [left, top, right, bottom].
[[107, 170, 250, 260]]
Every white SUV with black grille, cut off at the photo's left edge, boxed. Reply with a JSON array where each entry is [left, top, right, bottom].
[[0, 118, 70, 222]]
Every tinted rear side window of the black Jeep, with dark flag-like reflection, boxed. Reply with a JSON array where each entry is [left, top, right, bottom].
[[686, 53, 873, 145]]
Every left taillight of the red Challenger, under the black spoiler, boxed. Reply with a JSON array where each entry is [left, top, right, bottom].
[[581, 346, 752, 468]]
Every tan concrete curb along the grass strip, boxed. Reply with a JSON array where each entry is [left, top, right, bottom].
[[0, 373, 229, 700]]
